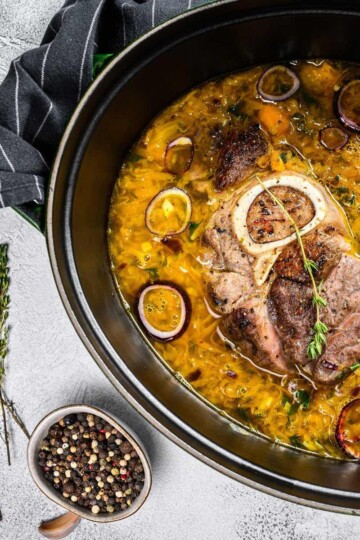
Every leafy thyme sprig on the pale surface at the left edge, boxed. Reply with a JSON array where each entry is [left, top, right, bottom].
[[0, 244, 11, 465]]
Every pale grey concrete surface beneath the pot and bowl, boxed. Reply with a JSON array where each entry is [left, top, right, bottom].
[[0, 0, 360, 540]]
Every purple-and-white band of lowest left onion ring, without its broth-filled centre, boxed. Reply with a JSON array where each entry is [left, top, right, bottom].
[[137, 281, 191, 341]]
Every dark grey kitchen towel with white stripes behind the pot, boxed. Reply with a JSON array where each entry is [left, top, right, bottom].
[[0, 0, 213, 228]]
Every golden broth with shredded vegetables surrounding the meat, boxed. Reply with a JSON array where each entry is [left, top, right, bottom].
[[109, 61, 360, 457]]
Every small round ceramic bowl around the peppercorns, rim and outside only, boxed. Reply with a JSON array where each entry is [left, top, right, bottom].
[[27, 405, 152, 523]]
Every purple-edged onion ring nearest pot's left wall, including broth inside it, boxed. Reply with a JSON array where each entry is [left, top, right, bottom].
[[137, 281, 191, 341]]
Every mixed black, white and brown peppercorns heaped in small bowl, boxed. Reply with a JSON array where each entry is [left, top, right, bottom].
[[38, 413, 145, 514]]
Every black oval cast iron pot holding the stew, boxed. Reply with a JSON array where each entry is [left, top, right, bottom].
[[47, 0, 360, 515]]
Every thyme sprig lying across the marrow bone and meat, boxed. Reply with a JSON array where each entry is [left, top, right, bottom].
[[255, 176, 329, 360]]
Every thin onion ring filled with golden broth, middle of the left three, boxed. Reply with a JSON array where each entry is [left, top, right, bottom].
[[145, 188, 192, 236]]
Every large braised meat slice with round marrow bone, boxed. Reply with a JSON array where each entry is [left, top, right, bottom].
[[204, 173, 360, 384]]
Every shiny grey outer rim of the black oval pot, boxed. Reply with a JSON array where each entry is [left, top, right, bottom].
[[46, 0, 360, 515]]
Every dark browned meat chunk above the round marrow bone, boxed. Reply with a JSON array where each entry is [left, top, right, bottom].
[[216, 125, 268, 191]]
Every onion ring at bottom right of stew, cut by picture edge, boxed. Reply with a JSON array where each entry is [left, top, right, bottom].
[[335, 399, 360, 459]]
